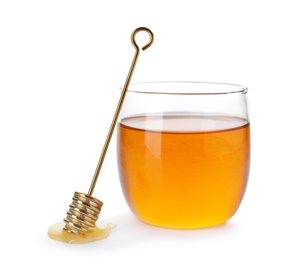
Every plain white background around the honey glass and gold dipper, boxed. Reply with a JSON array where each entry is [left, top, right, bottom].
[[0, 0, 303, 259]]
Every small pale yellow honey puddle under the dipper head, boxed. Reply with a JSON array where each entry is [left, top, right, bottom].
[[47, 221, 116, 244]]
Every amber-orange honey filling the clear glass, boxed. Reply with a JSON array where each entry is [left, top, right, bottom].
[[117, 115, 250, 228]]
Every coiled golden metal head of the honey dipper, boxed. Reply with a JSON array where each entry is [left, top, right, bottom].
[[64, 192, 103, 234]]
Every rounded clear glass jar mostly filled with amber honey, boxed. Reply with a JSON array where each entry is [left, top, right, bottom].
[[117, 82, 250, 229]]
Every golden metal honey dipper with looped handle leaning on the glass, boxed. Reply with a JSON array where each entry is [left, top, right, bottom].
[[50, 27, 154, 241]]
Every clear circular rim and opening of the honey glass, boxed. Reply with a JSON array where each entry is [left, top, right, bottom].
[[121, 81, 248, 95]]
